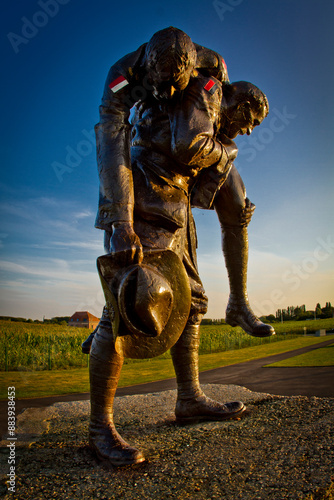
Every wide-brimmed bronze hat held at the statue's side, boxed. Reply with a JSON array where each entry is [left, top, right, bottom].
[[98, 250, 191, 359]]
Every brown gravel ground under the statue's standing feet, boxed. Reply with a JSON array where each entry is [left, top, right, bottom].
[[0, 385, 334, 500]]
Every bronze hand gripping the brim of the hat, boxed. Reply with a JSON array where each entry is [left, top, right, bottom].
[[110, 222, 143, 267]]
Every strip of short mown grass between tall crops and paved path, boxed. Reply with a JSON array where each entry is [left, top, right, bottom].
[[0, 335, 334, 399]]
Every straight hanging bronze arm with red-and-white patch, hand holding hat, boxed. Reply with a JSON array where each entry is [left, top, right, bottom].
[[95, 46, 144, 264]]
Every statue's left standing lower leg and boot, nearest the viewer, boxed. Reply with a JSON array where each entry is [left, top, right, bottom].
[[89, 322, 145, 467]]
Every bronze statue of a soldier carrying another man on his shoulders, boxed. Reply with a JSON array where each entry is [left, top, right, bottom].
[[89, 28, 273, 466]]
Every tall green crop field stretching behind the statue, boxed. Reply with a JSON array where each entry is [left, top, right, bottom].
[[0, 319, 334, 372]]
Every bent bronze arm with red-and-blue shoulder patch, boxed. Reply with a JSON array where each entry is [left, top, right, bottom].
[[171, 75, 238, 208]]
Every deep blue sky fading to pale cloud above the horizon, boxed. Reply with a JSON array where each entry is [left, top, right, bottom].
[[0, 0, 334, 319]]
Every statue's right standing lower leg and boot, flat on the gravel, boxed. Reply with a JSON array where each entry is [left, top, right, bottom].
[[171, 324, 246, 423]]
